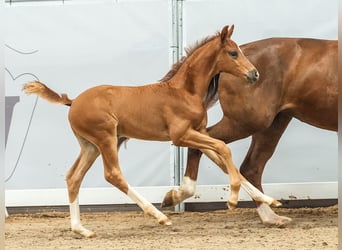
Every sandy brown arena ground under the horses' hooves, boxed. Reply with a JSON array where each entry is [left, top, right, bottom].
[[5, 206, 338, 250]]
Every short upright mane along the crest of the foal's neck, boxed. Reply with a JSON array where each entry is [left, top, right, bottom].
[[159, 32, 220, 82]]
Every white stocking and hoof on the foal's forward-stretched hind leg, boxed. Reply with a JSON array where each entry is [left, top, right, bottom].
[[127, 186, 171, 225]]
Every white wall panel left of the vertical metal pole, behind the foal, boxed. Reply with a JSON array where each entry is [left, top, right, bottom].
[[5, 1, 174, 189]]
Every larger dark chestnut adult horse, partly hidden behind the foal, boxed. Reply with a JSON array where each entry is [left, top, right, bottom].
[[163, 38, 338, 226]]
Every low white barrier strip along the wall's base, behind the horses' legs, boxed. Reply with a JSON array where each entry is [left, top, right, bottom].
[[6, 182, 338, 207]]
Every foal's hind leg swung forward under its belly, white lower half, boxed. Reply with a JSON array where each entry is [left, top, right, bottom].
[[98, 132, 171, 225]]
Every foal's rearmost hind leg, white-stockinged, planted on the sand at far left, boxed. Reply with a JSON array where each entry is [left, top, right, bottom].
[[66, 135, 99, 237]]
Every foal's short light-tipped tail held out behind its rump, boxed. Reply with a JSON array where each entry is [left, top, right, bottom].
[[23, 81, 72, 106]]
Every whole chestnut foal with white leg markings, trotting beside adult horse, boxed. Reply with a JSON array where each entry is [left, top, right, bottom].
[[24, 26, 280, 237]]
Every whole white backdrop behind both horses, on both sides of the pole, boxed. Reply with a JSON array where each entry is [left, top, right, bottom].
[[5, 0, 338, 206]]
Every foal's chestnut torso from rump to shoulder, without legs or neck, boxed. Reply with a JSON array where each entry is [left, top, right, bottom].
[[69, 82, 202, 141]]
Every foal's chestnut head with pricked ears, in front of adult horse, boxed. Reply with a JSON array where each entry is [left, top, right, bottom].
[[217, 25, 259, 83]]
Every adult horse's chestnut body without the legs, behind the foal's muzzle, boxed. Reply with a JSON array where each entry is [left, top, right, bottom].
[[219, 38, 338, 135]]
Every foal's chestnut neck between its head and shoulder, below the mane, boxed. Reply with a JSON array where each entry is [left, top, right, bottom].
[[171, 42, 218, 97]]
